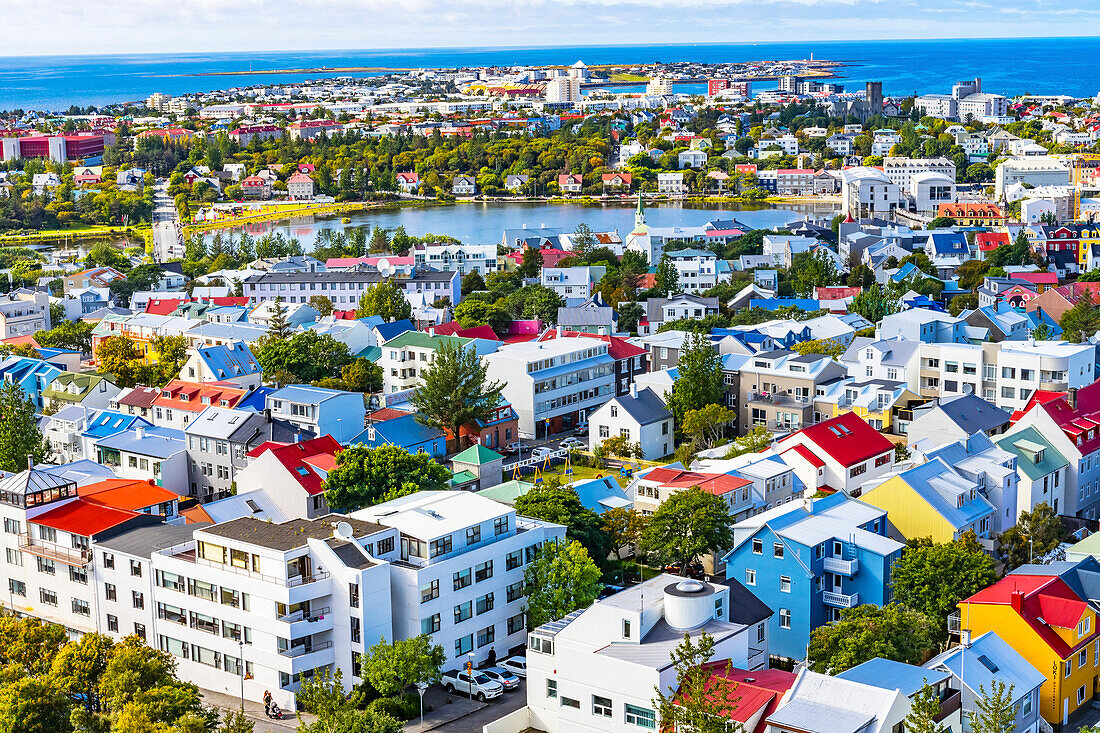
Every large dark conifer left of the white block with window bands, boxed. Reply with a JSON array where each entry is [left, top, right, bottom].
[[409, 339, 504, 447]]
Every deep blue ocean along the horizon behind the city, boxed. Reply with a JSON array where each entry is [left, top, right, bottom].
[[0, 37, 1100, 110]]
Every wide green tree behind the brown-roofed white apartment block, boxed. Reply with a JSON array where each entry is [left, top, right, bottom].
[[325, 445, 451, 512]]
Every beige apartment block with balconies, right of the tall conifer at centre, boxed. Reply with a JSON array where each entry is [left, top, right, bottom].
[[737, 349, 848, 435]]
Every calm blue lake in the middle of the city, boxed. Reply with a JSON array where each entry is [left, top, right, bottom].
[[198, 201, 837, 250]]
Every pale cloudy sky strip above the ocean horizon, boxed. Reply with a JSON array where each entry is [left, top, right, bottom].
[[0, 0, 1100, 55]]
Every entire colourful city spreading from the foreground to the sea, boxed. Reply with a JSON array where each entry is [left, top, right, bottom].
[[0, 51, 1100, 733]]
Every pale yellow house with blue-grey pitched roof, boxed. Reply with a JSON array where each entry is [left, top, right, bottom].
[[859, 458, 997, 543]]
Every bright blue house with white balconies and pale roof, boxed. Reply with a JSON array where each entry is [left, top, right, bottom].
[[723, 493, 905, 659]]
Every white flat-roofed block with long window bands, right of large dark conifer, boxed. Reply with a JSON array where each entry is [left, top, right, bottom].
[[484, 337, 616, 436]]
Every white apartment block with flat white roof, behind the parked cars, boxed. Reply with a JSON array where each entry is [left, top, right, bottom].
[[352, 491, 565, 666]]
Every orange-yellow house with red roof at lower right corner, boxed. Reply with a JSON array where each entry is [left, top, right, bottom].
[[959, 575, 1100, 725]]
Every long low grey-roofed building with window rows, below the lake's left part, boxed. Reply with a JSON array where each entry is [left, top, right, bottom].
[[241, 270, 462, 309]]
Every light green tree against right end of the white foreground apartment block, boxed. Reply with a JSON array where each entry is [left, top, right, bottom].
[[524, 539, 602, 628]]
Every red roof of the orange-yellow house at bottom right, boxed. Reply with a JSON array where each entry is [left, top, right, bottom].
[[963, 575, 1100, 659]]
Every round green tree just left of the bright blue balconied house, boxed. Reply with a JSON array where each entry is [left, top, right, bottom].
[[642, 486, 734, 575]]
